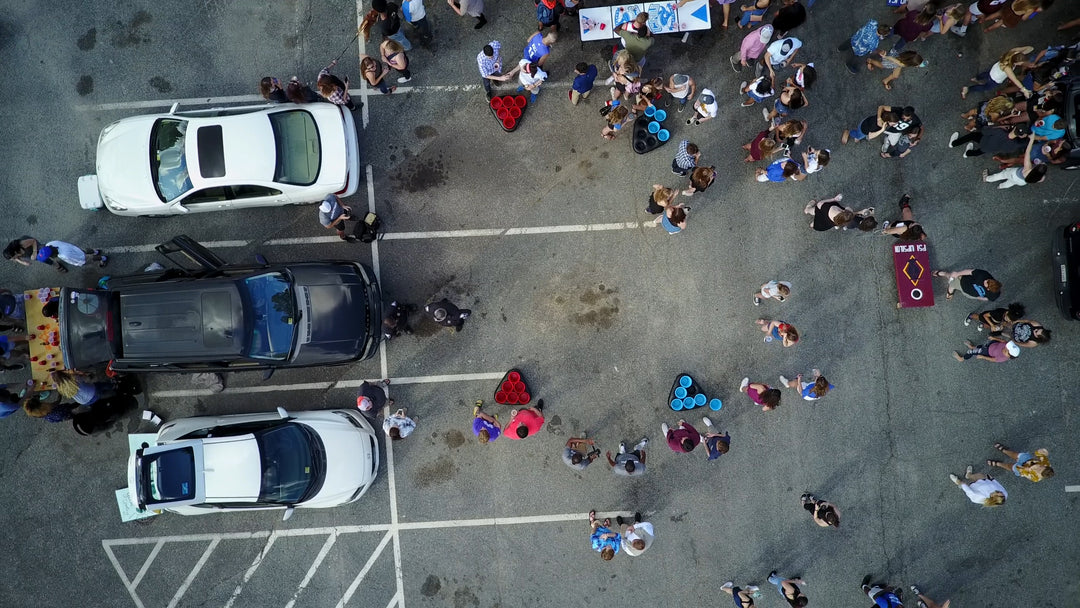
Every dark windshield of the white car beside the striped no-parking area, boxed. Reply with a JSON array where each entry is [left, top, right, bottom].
[[255, 423, 326, 504]]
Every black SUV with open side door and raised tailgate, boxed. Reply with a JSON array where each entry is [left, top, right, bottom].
[[59, 235, 382, 373]]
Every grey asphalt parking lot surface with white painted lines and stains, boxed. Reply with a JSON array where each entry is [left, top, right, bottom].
[[0, 0, 1080, 608]]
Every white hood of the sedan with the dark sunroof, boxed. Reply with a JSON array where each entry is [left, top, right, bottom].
[[97, 116, 165, 210]]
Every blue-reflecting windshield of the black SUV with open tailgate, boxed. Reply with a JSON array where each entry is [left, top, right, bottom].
[[242, 272, 297, 361]]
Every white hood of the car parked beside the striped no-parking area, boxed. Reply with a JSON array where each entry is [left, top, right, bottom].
[[302, 420, 378, 506]]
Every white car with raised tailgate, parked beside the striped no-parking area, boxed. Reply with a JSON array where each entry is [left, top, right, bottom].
[[127, 407, 379, 519]]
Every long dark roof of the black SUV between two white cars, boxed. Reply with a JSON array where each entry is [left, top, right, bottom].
[[120, 280, 244, 360]]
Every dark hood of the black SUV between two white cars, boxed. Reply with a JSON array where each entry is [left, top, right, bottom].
[[293, 266, 373, 365]]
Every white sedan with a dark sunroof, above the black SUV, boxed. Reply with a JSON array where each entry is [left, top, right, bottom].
[[79, 104, 361, 216]]
